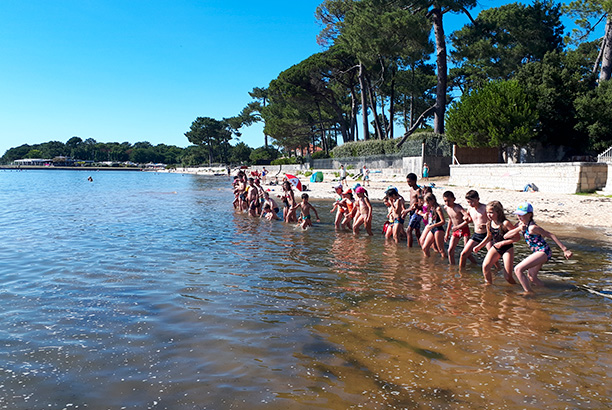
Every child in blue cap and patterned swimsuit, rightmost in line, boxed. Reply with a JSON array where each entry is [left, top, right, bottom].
[[504, 202, 572, 294]]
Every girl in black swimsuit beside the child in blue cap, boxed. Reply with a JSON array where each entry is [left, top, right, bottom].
[[474, 201, 519, 285]]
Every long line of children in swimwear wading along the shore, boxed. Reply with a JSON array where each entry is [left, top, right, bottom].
[[234, 173, 572, 293]]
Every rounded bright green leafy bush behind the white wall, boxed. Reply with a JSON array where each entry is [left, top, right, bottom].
[[446, 80, 538, 147]]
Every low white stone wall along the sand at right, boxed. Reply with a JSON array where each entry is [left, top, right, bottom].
[[449, 162, 609, 194]]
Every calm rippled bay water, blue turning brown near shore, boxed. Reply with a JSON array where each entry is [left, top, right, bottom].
[[0, 171, 612, 409]]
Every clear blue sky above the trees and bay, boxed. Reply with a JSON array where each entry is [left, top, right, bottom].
[[0, 0, 596, 155]]
